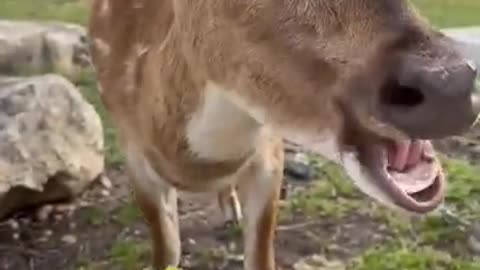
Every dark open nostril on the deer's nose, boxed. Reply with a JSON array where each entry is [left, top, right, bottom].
[[381, 80, 425, 108]]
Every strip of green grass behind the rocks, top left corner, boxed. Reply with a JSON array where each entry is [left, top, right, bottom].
[[0, 0, 90, 24]]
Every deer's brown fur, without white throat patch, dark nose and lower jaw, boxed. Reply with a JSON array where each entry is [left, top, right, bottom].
[[89, 0, 476, 270]]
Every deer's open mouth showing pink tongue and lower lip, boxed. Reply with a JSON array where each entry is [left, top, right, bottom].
[[364, 140, 445, 214]]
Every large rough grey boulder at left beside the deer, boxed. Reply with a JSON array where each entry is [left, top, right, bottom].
[[0, 75, 104, 219]]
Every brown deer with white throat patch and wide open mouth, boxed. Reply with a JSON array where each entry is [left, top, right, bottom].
[[88, 0, 480, 270]]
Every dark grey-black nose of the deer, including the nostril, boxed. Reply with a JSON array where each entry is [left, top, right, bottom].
[[380, 55, 480, 139]]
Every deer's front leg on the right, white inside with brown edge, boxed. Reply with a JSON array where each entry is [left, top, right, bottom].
[[239, 140, 283, 270]]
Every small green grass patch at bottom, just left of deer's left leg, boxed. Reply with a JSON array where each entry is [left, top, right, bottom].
[[110, 240, 150, 270]]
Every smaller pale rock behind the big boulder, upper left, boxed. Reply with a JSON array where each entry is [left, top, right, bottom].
[[0, 20, 90, 76]]
